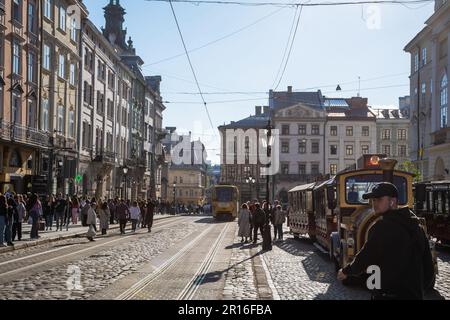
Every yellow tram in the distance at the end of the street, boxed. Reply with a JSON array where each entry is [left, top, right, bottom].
[[211, 185, 239, 220]]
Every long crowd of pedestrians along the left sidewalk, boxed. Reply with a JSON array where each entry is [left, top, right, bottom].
[[0, 193, 163, 247]]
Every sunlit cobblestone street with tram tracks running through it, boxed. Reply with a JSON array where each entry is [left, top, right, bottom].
[[0, 216, 450, 300]]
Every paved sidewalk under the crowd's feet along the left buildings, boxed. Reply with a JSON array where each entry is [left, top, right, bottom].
[[0, 214, 175, 254]]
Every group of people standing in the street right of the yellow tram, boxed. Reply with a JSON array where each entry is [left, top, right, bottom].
[[238, 200, 287, 243]]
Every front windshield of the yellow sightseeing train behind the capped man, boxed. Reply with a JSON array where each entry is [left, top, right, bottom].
[[345, 174, 408, 205]]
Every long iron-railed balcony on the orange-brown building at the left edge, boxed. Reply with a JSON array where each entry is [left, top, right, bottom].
[[0, 121, 50, 148]]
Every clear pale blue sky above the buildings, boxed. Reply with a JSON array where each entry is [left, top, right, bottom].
[[84, 0, 434, 163]]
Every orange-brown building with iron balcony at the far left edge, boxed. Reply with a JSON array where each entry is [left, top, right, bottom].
[[0, 0, 49, 192]]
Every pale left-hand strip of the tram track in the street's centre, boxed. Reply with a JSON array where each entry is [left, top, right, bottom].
[[114, 225, 213, 300]]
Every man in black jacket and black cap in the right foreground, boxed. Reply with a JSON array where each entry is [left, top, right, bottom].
[[338, 182, 434, 300]]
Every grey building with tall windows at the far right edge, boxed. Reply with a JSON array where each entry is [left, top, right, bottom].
[[404, 0, 450, 180]]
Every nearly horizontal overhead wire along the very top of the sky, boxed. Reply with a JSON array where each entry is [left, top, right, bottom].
[[145, 0, 434, 9]]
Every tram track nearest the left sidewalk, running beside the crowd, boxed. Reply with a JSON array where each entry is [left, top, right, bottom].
[[0, 217, 190, 283]]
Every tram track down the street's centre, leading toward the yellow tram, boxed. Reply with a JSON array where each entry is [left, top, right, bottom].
[[115, 224, 229, 300]]
